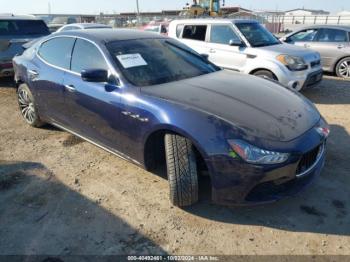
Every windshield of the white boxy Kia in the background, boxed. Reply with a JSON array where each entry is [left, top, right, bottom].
[[236, 23, 281, 47]]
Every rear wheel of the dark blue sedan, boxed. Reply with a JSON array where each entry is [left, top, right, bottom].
[[17, 84, 45, 127]]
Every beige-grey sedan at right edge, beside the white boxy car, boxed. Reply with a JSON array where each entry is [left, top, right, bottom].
[[281, 25, 350, 78]]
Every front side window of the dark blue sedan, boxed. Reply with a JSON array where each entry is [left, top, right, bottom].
[[71, 39, 108, 73]]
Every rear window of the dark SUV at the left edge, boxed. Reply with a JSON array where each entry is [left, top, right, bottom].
[[0, 20, 50, 35]]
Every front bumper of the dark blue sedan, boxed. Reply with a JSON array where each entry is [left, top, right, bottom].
[[207, 127, 326, 206]]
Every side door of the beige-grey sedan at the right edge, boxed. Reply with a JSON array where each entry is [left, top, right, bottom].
[[312, 28, 349, 71]]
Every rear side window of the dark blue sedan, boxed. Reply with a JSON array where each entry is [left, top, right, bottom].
[[39, 37, 75, 69]]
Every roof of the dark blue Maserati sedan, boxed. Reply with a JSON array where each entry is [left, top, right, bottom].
[[55, 28, 165, 43]]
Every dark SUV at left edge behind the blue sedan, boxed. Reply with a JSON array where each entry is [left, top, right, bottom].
[[0, 14, 50, 77]]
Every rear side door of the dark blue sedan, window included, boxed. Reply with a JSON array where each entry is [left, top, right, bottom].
[[32, 37, 75, 123]]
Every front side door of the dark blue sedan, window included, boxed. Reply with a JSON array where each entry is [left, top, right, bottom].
[[64, 39, 125, 149]]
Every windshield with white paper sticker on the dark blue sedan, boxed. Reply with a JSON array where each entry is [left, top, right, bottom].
[[107, 38, 220, 86]]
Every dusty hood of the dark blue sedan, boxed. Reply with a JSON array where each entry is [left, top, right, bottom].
[[141, 70, 320, 141]]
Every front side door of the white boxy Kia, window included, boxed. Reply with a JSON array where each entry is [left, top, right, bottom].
[[207, 24, 247, 71]]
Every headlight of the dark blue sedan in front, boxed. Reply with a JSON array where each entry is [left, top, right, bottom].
[[228, 140, 289, 164]]
